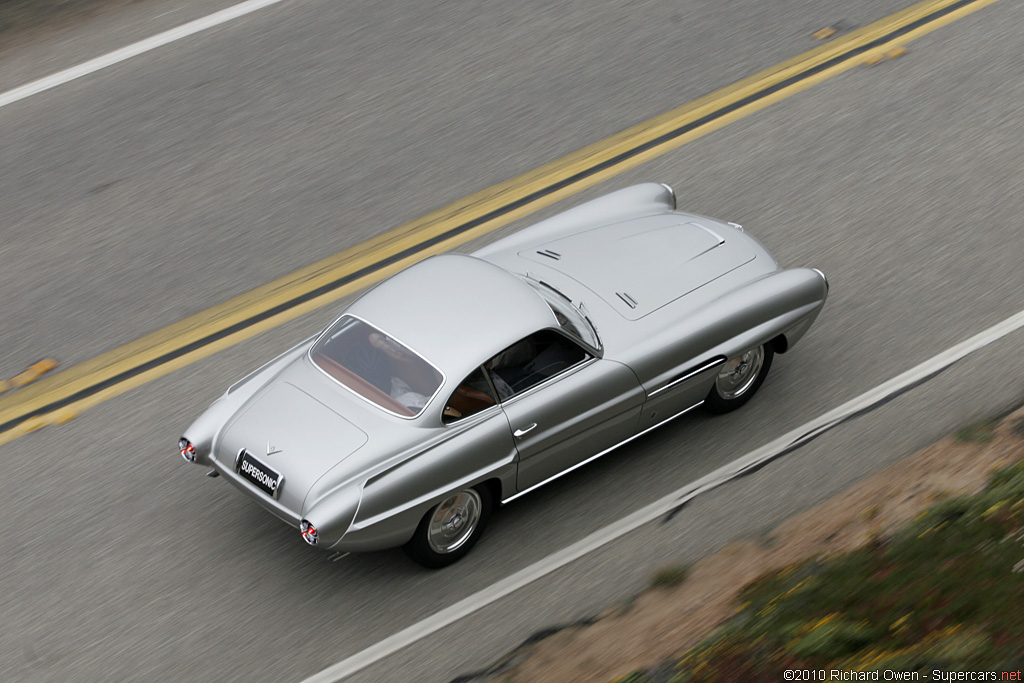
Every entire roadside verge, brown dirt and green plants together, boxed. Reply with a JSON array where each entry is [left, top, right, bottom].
[[475, 409, 1024, 683]]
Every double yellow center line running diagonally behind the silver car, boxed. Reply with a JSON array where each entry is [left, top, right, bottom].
[[0, 0, 995, 443]]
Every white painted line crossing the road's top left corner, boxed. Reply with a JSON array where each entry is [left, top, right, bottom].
[[0, 0, 283, 106]]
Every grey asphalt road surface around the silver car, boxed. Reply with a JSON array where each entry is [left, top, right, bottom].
[[0, 0, 1024, 681]]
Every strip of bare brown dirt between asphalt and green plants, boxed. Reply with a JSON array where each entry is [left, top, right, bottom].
[[476, 409, 1024, 683]]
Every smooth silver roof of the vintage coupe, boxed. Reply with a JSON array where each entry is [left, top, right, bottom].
[[345, 254, 557, 382]]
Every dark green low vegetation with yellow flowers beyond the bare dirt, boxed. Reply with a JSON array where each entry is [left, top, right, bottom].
[[618, 463, 1024, 683]]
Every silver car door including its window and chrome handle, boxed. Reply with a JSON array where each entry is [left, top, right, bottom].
[[485, 330, 644, 493]]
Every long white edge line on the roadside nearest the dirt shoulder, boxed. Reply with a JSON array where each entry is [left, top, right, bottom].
[[302, 311, 1024, 683]]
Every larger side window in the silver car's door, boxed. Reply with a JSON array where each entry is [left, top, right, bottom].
[[483, 330, 590, 400]]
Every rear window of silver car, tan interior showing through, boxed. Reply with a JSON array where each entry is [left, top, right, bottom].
[[309, 315, 443, 418]]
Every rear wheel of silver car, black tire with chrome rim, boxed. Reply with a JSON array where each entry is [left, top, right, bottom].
[[402, 485, 494, 569]]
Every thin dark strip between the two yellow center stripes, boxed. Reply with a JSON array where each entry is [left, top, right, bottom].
[[0, 0, 988, 444]]
